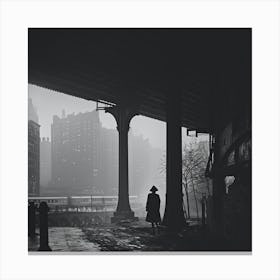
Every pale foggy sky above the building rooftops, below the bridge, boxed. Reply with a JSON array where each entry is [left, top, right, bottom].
[[28, 84, 166, 150]]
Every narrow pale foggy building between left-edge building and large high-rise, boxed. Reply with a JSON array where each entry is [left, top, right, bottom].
[[40, 137, 52, 187]]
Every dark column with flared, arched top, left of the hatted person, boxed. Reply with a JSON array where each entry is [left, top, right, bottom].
[[105, 105, 136, 222]]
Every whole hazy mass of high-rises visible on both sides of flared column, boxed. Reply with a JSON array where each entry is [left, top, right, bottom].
[[48, 111, 164, 195]]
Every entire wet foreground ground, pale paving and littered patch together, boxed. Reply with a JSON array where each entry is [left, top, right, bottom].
[[29, 220, 234, 252]]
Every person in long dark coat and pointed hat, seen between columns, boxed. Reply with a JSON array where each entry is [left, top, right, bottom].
[[146, 186, 161, 234]]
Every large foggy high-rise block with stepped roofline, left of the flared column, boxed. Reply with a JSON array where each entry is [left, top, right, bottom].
[[51, 111, 101, 194]]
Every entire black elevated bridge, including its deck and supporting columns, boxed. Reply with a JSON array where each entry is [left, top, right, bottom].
[[28, 28, 251, 237]]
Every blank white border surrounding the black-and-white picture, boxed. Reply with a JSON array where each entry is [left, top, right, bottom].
[[0, 0, 280, 280]]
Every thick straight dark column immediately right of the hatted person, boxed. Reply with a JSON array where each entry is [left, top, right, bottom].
[[163, 92, 185, 230]]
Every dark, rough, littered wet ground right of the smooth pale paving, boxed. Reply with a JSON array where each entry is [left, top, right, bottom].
[[83, 220, 211, 252]]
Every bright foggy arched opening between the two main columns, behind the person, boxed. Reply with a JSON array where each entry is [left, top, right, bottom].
[[128, 116, 166, 217]]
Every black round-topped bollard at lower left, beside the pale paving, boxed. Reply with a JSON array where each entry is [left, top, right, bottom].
[[39, 201, 51, 251]]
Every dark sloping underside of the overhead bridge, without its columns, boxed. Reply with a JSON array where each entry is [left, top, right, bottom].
[[28, 28, 251, 132]]
